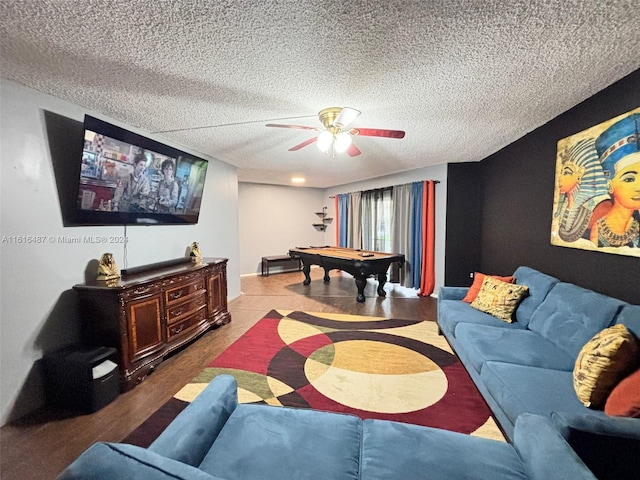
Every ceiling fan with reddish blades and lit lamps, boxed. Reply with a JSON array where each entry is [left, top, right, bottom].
[[266, 107, 404, 157]]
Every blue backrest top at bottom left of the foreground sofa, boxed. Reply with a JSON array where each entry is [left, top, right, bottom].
[[58, 442, 224, 480]]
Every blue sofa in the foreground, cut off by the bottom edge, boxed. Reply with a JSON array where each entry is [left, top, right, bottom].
[[59, 375, 596, 480]]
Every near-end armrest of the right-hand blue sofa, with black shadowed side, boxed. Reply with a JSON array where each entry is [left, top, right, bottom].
[[551, 411, 640, 480]]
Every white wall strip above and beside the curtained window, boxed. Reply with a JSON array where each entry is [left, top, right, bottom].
[[324, 164, 447, 294]]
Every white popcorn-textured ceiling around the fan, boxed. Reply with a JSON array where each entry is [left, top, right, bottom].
[[0, 0, 640, 187]]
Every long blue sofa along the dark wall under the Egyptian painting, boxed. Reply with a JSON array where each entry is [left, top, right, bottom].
[[438, 266, 640, 479]]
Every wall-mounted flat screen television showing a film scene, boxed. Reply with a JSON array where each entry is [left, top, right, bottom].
[[76, 115, 208, 225]]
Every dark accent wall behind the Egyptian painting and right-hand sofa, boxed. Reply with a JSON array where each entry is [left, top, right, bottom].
[[445, 70, 640, 304]]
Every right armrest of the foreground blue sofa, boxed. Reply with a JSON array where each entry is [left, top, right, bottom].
[[513, 413, 596, 480]]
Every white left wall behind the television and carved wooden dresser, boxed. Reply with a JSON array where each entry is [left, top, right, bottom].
[[0, 80, 240, 424]]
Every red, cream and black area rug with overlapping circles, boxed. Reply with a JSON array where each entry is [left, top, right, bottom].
[[123, 310, 504, 447]]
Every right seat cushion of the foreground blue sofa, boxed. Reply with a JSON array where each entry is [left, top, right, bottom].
[[362, 420, 527, 480]]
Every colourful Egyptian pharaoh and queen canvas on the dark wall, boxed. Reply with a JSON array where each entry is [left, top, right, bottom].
[[551, 107, 640, 257]]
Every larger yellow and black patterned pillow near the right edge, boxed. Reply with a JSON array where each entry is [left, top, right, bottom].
[[573, 324, 639, 408]]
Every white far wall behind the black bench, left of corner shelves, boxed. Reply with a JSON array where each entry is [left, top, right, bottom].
[[238, 182, 328, 274]]
